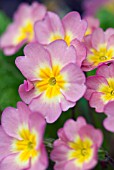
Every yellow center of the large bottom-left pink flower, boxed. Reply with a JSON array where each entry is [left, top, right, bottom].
[[11, 125, 40, 164]]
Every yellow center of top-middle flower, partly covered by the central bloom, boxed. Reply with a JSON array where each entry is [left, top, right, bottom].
[[49, 32, 73, 46]]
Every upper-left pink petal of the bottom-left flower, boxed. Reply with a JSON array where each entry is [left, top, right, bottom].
[[1, 102, 31, 139]]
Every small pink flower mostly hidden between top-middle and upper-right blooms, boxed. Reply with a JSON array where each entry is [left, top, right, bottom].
[[84, 16, 100, 36]]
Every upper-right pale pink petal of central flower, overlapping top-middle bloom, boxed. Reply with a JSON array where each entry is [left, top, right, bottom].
[[46, 40, 77, 67]]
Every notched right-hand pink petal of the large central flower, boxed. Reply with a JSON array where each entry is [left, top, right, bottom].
[[61, 64, 86, 102]]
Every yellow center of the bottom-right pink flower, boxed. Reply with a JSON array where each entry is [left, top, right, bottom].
[[68, 136, 93, 168]]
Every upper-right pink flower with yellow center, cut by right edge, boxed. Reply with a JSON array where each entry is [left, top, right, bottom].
[[82, 28, 114, 71]]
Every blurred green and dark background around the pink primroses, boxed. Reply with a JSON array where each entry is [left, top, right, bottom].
[[0, 0, 114, 170]]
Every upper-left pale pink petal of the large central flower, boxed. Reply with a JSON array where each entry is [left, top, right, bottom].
[[15, 43, 51, 80]]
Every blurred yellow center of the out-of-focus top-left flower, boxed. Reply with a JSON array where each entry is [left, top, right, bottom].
[[14, 20, 34, 44]]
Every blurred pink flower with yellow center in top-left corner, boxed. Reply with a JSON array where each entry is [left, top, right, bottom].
[[0, 2, 46, 55]]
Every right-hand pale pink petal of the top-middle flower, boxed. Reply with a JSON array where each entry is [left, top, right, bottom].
[[62, 12, 87, 40]]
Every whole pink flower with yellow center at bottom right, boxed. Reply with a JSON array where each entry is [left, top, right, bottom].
[[51, 117, 103, 170]]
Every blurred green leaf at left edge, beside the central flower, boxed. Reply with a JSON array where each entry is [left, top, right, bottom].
[[0, 51, 24, 111]]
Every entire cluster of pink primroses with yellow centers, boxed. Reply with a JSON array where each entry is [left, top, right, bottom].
[[0, 2, 114, 170]]
